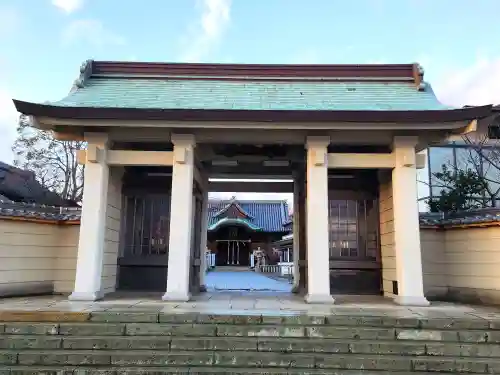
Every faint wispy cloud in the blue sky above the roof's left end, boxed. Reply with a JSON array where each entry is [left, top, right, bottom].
[[62, 19, 126, 47]]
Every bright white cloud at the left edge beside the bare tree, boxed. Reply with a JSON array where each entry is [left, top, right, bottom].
[[0, 87, 19, 163]]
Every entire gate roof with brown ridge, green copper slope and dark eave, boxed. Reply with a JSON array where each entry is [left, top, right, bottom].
[[14, 60, 491, 122]]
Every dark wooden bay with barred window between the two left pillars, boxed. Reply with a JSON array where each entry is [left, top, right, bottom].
[[117, 167, 172, 292]]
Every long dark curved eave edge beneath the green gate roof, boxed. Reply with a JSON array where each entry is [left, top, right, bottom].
[[13, 99, 492, 123]]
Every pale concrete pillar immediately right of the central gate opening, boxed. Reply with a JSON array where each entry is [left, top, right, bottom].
[[305, 137, 334, 303]]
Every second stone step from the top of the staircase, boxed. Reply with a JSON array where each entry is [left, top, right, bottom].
[[0, 322, 500, 343]]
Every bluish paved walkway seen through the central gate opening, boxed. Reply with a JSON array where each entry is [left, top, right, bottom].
[[205, 270, 292, 293]]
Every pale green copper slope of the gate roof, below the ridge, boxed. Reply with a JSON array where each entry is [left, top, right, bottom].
[[50, 76, 450, 111]]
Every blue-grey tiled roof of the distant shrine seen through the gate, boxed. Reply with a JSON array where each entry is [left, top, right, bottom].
[[208, 199, 289, 232]]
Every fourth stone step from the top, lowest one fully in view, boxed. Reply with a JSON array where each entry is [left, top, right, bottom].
[[0, 350, 500, 374]]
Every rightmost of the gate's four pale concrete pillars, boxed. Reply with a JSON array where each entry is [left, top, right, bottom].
[[392, 137, 429, 306]]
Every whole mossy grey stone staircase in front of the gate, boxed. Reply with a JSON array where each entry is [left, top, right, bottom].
[[0, 311, 500, 375]]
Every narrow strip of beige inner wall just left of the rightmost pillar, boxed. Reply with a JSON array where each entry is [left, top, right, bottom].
[[379, 172, 397, 297]]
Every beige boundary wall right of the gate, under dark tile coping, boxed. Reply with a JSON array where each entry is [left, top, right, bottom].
[[421, 226, 500, 304]]
